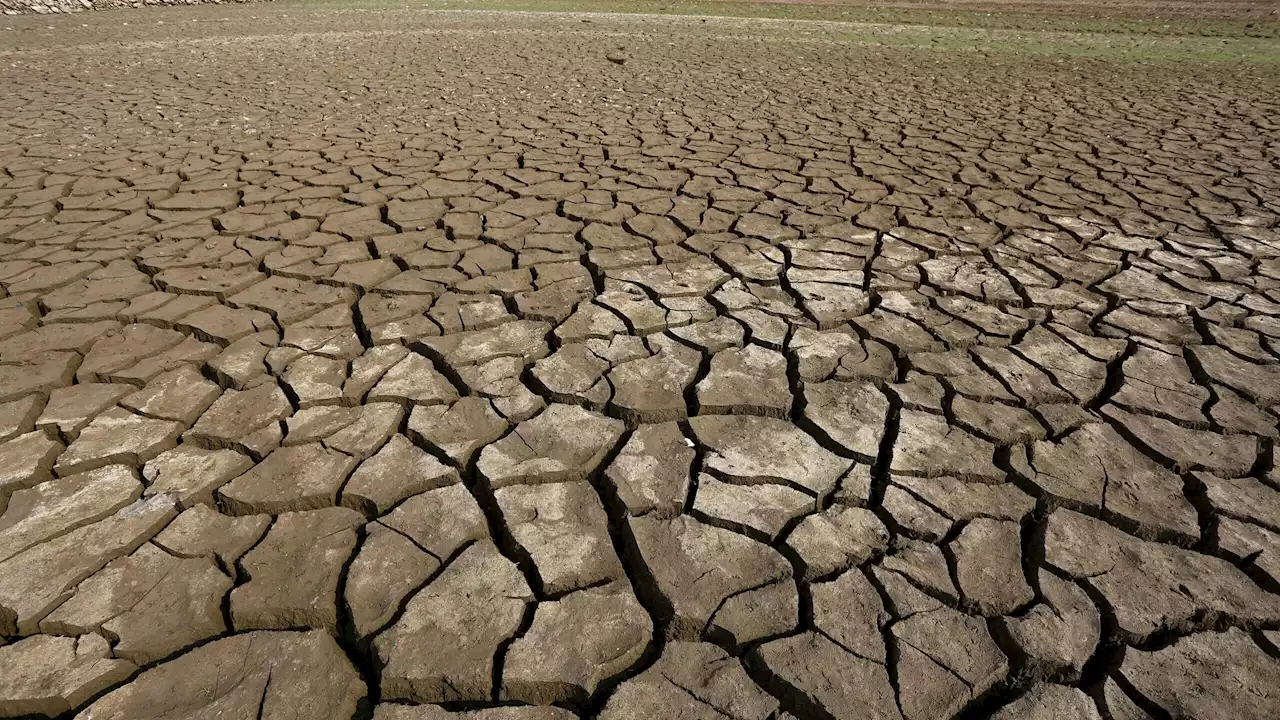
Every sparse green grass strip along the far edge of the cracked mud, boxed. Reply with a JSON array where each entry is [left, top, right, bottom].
[[8, 0, 1280, 65]]
